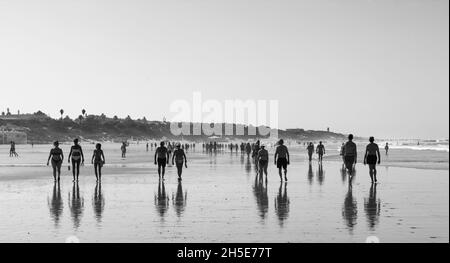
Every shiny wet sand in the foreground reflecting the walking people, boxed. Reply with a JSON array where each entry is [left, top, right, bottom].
[[0, 145, 449, 243]]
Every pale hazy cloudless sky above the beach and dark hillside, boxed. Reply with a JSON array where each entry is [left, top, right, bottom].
[[0, 0, 449, 138]]
